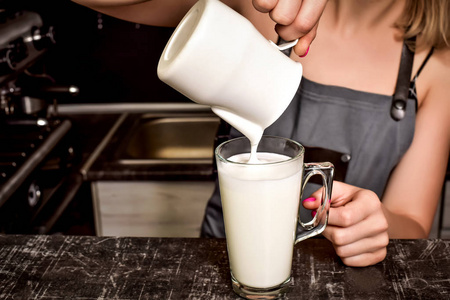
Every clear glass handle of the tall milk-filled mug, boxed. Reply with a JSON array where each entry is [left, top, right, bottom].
[[295, 162, 334, 244]]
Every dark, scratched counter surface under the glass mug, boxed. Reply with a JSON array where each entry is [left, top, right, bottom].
[[0, 235, 450, 300]]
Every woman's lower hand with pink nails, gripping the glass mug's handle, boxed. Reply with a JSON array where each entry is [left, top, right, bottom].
[[303, 181, 389, 267]]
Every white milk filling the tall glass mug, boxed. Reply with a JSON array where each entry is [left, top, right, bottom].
[[218, 152, 303, 288]]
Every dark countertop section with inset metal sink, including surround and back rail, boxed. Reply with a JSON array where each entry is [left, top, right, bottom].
[[77, 103, 221, 182]]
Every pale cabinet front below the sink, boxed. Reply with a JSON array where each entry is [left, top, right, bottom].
[[92, 181, 214, 237]]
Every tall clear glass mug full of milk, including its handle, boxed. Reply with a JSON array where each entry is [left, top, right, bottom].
[[215, 136, 334, 299]]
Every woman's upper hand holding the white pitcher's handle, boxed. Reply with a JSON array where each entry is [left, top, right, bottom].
[[252, 0, 327, 57]]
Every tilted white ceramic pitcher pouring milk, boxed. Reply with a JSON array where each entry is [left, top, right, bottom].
[[158, 0, 303, 142]]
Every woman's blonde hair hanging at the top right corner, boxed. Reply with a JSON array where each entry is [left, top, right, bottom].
[[397, 0, 450, 50]]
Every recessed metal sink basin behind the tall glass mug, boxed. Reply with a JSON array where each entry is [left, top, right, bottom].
[[118, 114, 220, 164]]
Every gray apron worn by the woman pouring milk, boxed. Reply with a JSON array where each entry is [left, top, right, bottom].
[[201, 41, 431, 237]]
